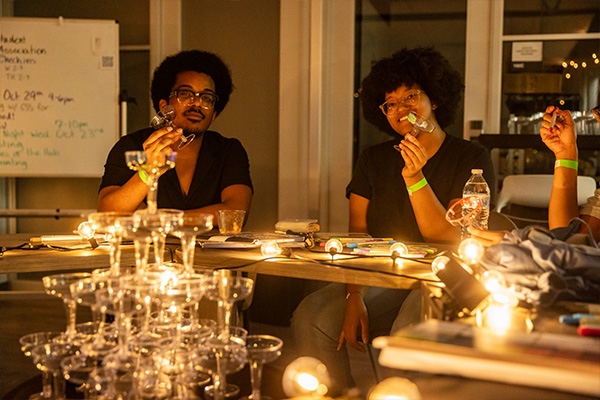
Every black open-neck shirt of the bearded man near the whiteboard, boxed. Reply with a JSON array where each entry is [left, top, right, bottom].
[[100, 129, 252, 210]]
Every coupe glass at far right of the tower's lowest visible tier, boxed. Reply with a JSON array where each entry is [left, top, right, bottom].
[[245, 335, 283, 400]]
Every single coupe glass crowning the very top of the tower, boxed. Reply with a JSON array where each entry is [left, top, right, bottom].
[[125, 151, 177, 214]]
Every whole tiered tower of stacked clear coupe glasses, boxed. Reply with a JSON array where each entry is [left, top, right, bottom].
[[20, 152, 282, 400]]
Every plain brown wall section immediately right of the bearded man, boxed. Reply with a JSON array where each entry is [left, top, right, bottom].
[[182, 0, 279, 230]]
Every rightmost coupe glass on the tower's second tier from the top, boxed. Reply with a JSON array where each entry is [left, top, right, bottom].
[[171, 213, 214, 274]]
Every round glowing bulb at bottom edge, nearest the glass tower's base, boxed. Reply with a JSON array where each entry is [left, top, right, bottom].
[[282, 357, 330, 397]]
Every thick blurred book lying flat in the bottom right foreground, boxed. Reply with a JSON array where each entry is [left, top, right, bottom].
[[373, 320, 600, 396]]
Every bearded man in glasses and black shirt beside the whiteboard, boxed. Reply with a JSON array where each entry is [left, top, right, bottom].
[[98, 50, 253, 220]]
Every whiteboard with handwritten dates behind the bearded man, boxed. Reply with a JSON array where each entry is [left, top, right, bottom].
[[0, 18, 119, 177]]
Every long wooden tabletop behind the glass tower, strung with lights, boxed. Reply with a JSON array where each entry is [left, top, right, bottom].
[[0, 234, 436, 289]]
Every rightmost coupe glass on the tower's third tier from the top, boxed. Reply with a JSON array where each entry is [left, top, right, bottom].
[[204, 269, 254, 342]]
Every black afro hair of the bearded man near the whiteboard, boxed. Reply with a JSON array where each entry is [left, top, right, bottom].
[[150, 50, 233, 114]]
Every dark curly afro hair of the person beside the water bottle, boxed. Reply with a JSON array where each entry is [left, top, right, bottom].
[[360, 47, 465, 137]]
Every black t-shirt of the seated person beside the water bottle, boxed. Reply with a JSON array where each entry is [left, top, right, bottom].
[[346, 135, 496, 241]]
